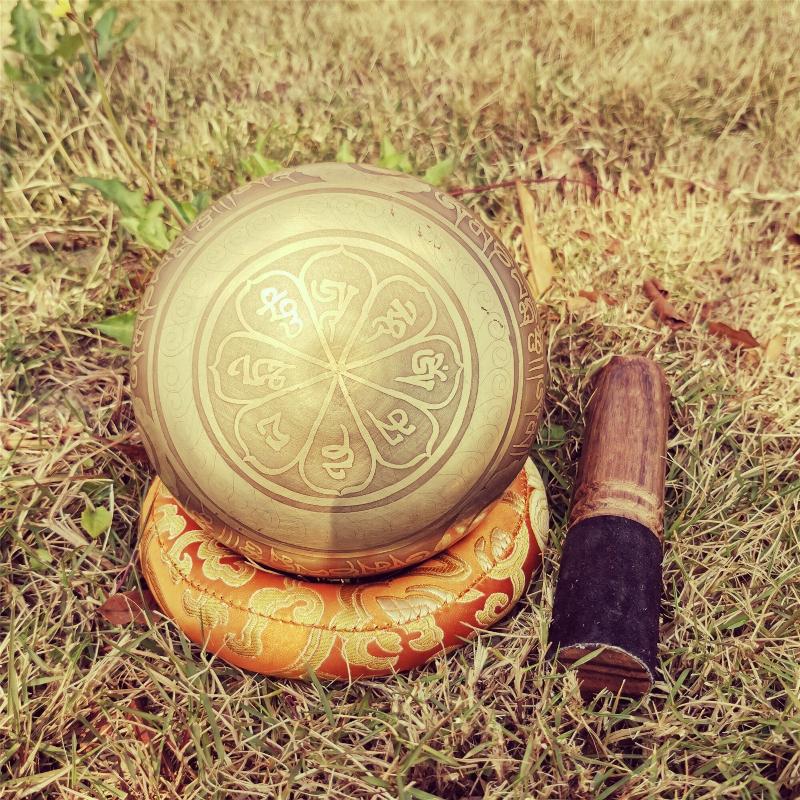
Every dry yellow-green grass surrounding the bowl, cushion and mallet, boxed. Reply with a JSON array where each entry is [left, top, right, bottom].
[[0, 0, 800, 800]]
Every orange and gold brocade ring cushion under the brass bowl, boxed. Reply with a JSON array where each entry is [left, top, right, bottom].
[[139, 461, 548, 679]]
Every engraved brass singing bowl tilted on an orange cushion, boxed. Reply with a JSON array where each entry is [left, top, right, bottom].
[[131, 164, 546, 577]]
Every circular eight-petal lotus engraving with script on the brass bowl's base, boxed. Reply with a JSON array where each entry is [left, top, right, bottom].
[[196, 241, 478, 510]]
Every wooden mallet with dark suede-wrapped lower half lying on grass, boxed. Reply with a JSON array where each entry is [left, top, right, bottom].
[[550, 356, 669, 696]]
